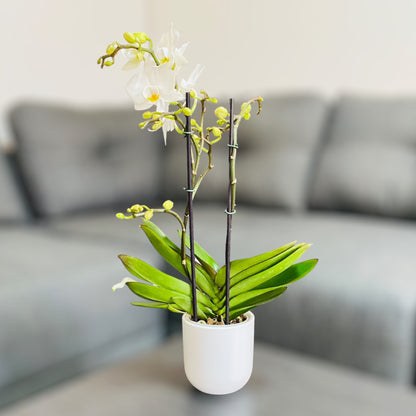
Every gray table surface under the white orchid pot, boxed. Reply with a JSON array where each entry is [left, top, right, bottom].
[[0, 337, 416, 416]]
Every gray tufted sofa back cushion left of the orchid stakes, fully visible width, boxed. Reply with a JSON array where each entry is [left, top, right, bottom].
[[10, 103, 163, 216]]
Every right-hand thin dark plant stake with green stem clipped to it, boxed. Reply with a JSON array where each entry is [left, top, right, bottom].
[[225, 98, 238, 325]]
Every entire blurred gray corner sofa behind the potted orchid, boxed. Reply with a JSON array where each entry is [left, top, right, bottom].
[[0, 94, 416, 405]]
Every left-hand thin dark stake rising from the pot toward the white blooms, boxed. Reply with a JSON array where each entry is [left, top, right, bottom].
[[185, 92, 198, 322]]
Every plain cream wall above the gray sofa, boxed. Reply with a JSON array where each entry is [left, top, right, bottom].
[[0, 0, 416, 144]]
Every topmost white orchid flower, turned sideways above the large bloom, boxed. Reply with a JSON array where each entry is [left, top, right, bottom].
[[156, 24, 189, 71]]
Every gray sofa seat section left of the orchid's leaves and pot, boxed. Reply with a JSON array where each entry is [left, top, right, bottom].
[[0, 228, 165, 405]]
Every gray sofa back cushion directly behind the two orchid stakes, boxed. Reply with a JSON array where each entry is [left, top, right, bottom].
[[165, 94, 327, 210]]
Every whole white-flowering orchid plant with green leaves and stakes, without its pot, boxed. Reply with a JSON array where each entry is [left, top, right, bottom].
[[98, 27, 317, 324]]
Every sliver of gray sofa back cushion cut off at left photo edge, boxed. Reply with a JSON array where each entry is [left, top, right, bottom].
[[0, 151, 26, 224]]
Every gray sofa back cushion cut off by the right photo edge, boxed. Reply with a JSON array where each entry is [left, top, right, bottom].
[[311, 96, 416, 218]]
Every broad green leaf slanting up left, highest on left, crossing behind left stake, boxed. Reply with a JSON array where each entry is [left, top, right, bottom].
[[141, 221, 218, 298]]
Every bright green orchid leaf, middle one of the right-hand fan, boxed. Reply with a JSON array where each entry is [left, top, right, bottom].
[[230, 244, 310, 298]]
